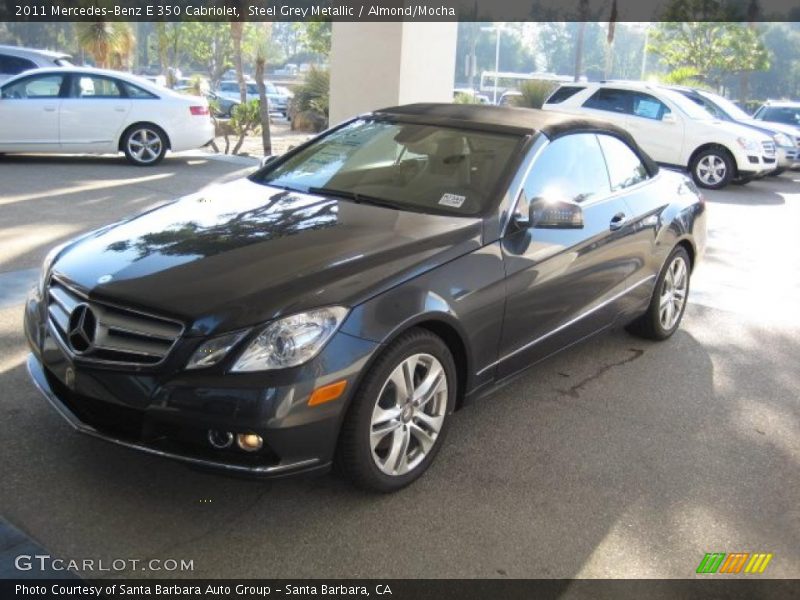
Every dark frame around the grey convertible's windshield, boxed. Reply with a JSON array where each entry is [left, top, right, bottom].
[[247, 114, 528, 219]]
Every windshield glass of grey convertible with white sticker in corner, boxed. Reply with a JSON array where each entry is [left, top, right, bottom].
[[253, 119, 522, 216]]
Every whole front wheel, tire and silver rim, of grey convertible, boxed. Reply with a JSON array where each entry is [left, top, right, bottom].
[[336, 329, 457, 493]]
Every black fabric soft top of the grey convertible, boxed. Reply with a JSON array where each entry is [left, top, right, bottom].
[[372, 103, 658, 176]]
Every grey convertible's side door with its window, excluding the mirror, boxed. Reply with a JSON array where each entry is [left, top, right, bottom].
[[497, 134, 636, 378]]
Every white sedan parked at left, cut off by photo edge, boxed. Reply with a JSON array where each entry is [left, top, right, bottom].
[[0, 67, 214, 166]]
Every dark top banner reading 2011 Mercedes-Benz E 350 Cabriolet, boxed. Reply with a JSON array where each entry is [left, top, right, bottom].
[[0, 0, 800, 22]]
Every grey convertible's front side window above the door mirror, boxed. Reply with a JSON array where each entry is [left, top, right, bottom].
[[524, 133, 611, 203]]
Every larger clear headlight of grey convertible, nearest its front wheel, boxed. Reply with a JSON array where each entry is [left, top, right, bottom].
[[231, 306, 347, 372]]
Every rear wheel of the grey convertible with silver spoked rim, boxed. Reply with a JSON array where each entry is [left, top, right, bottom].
[[628, 246, 691, 341]]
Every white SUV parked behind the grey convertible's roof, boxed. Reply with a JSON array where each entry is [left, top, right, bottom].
[[542, 82, 777, 189]]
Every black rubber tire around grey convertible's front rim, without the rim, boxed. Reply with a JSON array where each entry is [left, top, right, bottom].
[[337, 329, 458, 492]]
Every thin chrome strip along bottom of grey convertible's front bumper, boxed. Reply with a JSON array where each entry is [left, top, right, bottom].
[[26, 353, 320, 475]]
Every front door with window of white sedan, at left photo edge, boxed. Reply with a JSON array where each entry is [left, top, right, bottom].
[[0, 75, 65, 152]]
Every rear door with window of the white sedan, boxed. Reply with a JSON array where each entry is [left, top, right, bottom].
[[61, 75, 132, 152]]
